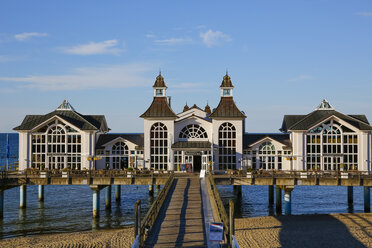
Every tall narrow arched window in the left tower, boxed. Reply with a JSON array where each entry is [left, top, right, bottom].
[[150, 122, 168, 170]]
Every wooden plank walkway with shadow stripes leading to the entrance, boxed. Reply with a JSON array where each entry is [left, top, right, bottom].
[[145, 177, 207, 247]]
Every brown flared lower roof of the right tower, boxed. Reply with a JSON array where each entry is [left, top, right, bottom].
[[209, 97, 246, 119]]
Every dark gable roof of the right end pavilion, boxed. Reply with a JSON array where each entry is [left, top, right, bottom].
[[281, 110, 372, 132]]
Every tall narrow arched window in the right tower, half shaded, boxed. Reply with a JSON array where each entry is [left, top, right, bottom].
[[218, 122, 236, 170]]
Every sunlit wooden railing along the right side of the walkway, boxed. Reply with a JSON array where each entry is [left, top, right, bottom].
[[207, 174, 230, 244]]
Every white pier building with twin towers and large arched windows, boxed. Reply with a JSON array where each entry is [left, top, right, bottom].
[[14, 74, 372, 171]]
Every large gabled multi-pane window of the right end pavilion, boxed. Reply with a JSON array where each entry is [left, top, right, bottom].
[[306, 120, 358, 170]]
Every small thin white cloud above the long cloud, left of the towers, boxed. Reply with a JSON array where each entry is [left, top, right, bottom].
[[62, 40, 124, 55]]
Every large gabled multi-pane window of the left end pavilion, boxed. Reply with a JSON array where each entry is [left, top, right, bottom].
[[32, 120, 81, 169]]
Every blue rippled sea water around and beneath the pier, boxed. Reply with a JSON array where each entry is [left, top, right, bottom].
[[0, 133, 370, 238]]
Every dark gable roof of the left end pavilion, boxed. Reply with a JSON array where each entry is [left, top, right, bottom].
[[13, 110, 106, 131]]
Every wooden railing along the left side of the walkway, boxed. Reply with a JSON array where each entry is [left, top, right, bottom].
[[139, 172, 174, 247]]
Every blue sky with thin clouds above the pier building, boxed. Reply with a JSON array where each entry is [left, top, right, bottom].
[[0, 0, 372, 132]]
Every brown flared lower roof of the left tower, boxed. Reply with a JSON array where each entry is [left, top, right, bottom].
[[140, 97, 177, 118]]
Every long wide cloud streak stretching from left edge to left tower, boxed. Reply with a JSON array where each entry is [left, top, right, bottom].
[[0, 63, 157, 91]]
